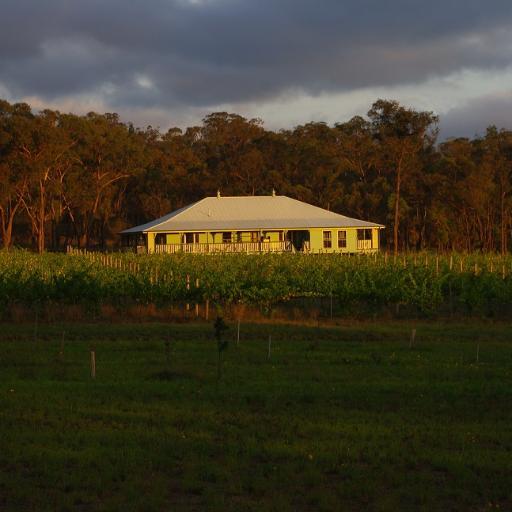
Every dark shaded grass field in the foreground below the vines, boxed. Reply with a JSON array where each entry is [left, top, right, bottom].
[[0, 323, 512, 512]]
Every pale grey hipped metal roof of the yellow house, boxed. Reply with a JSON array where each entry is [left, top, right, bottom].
[[122, 196, 384, 234]]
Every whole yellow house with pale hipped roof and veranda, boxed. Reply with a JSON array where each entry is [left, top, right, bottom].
[[121, 193, 384, 254]]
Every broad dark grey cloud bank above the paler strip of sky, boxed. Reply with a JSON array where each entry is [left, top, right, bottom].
[[0, 0, 512, 108]]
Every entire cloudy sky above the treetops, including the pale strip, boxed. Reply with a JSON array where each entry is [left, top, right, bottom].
[[0, 0, 512, 139]]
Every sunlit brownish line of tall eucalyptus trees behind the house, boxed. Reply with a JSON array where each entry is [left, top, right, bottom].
[[0, 100, 512, 253]]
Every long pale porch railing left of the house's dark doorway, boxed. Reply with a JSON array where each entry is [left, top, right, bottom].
[[155, 240, 292, 254]]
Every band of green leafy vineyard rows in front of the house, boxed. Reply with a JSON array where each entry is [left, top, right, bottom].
[[0, 251, 512, 315]]
